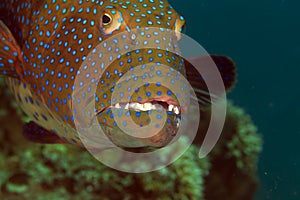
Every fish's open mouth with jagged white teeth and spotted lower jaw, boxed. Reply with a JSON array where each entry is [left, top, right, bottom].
[[96, 97, 185, 148]]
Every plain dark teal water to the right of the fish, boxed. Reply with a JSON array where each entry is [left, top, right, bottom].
[[170, 0, 300, 200]]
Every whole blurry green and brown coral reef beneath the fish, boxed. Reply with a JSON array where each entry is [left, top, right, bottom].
[[0, 79, 261, 200]]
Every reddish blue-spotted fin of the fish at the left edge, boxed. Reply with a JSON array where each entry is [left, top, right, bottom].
[[0, 20, 23, 80]]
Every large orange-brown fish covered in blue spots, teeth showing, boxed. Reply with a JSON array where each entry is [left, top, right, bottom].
[[0, 0, 236, 149]]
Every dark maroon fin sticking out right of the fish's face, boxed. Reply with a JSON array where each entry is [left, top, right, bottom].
[[184, 55, 236, 106]]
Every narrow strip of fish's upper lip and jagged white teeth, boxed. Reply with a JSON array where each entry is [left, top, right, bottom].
[[96, 97, 184, 115]]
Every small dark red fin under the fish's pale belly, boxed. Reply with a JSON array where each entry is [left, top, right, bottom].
[[23, 121, 67, 144]]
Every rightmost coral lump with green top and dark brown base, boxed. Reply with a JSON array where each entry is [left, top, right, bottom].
[[196, 102, 262, 200]]
